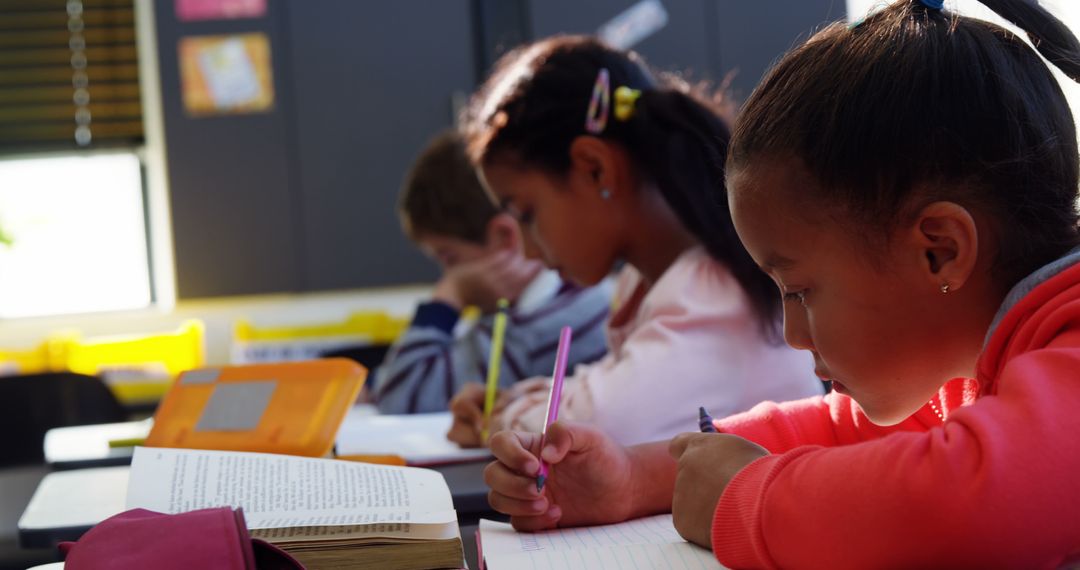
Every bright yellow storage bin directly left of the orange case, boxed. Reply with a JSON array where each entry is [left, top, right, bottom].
[[63, 320, 206, 404]]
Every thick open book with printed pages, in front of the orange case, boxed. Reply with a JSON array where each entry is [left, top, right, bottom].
[[126, 447, 464, 569]]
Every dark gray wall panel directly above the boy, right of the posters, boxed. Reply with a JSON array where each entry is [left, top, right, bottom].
[[288, 0, 475, 290]]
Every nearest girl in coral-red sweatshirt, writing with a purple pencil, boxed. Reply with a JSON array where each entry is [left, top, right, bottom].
[[485, 0, 1080, 568]]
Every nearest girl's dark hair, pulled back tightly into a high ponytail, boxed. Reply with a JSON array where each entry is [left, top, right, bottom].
[[728, 0, 1080, 285]]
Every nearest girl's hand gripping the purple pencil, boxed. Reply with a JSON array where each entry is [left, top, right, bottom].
[[484, 422, 634, 530]]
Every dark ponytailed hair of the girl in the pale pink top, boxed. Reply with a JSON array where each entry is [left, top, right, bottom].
[[463, 36, 780, 339]]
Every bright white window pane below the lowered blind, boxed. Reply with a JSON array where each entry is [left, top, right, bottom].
[[0, 152, 152, 318]]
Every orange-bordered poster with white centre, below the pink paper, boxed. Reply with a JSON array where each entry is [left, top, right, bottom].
[[177, 33, 273, 117]]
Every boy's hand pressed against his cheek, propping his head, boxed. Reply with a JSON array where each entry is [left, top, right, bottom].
[[433, 249, 543, 313]]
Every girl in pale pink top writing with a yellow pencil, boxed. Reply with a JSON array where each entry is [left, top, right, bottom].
[[449, 37, 822, 445]]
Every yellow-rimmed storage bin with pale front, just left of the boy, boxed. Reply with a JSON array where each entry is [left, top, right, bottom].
[[231, 311, 408, 364]]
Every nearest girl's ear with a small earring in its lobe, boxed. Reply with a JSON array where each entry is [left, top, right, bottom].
[[913, 202, 978, 293]]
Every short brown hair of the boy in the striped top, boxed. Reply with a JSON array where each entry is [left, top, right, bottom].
[[397, 131, 498, 244]]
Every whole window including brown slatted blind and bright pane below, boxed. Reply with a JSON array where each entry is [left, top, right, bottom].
[[0, 0, 153, 318]]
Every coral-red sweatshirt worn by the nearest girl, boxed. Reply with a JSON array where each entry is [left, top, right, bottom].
[[713, 260, 1080, 569]]
